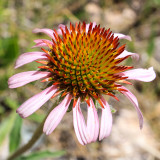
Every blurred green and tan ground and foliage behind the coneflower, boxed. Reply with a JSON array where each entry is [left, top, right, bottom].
[[0, 0, 160, 160]]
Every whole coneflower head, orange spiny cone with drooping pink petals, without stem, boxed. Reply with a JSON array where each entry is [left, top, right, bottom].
[[8, 22, 155, 145]]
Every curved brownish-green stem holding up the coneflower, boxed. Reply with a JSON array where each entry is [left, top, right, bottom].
[[7, 102, 57, 160]]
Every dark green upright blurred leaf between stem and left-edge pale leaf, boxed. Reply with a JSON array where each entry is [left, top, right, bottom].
[[9, 114, 22, 152]]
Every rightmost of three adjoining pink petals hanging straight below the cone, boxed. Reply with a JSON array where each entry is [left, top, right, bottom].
[[99, 96, 112, 141]]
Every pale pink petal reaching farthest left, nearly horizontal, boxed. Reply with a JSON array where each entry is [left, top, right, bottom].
[[8, 71, 51, 88]]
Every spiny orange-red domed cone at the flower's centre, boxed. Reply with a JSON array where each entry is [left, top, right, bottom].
[[39, 23, 132, 102]]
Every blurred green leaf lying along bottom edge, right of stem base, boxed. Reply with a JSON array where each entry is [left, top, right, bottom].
[[16, 151, 66, 160]]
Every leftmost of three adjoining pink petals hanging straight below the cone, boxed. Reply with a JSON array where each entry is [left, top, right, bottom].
[[73, 98, 90, 145]]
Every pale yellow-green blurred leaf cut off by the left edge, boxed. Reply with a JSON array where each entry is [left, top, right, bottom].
[[0, 111, 16, 145]]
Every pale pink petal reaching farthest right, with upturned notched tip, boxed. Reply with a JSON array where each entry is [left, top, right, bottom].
[[119, 67, 156, 82]]
